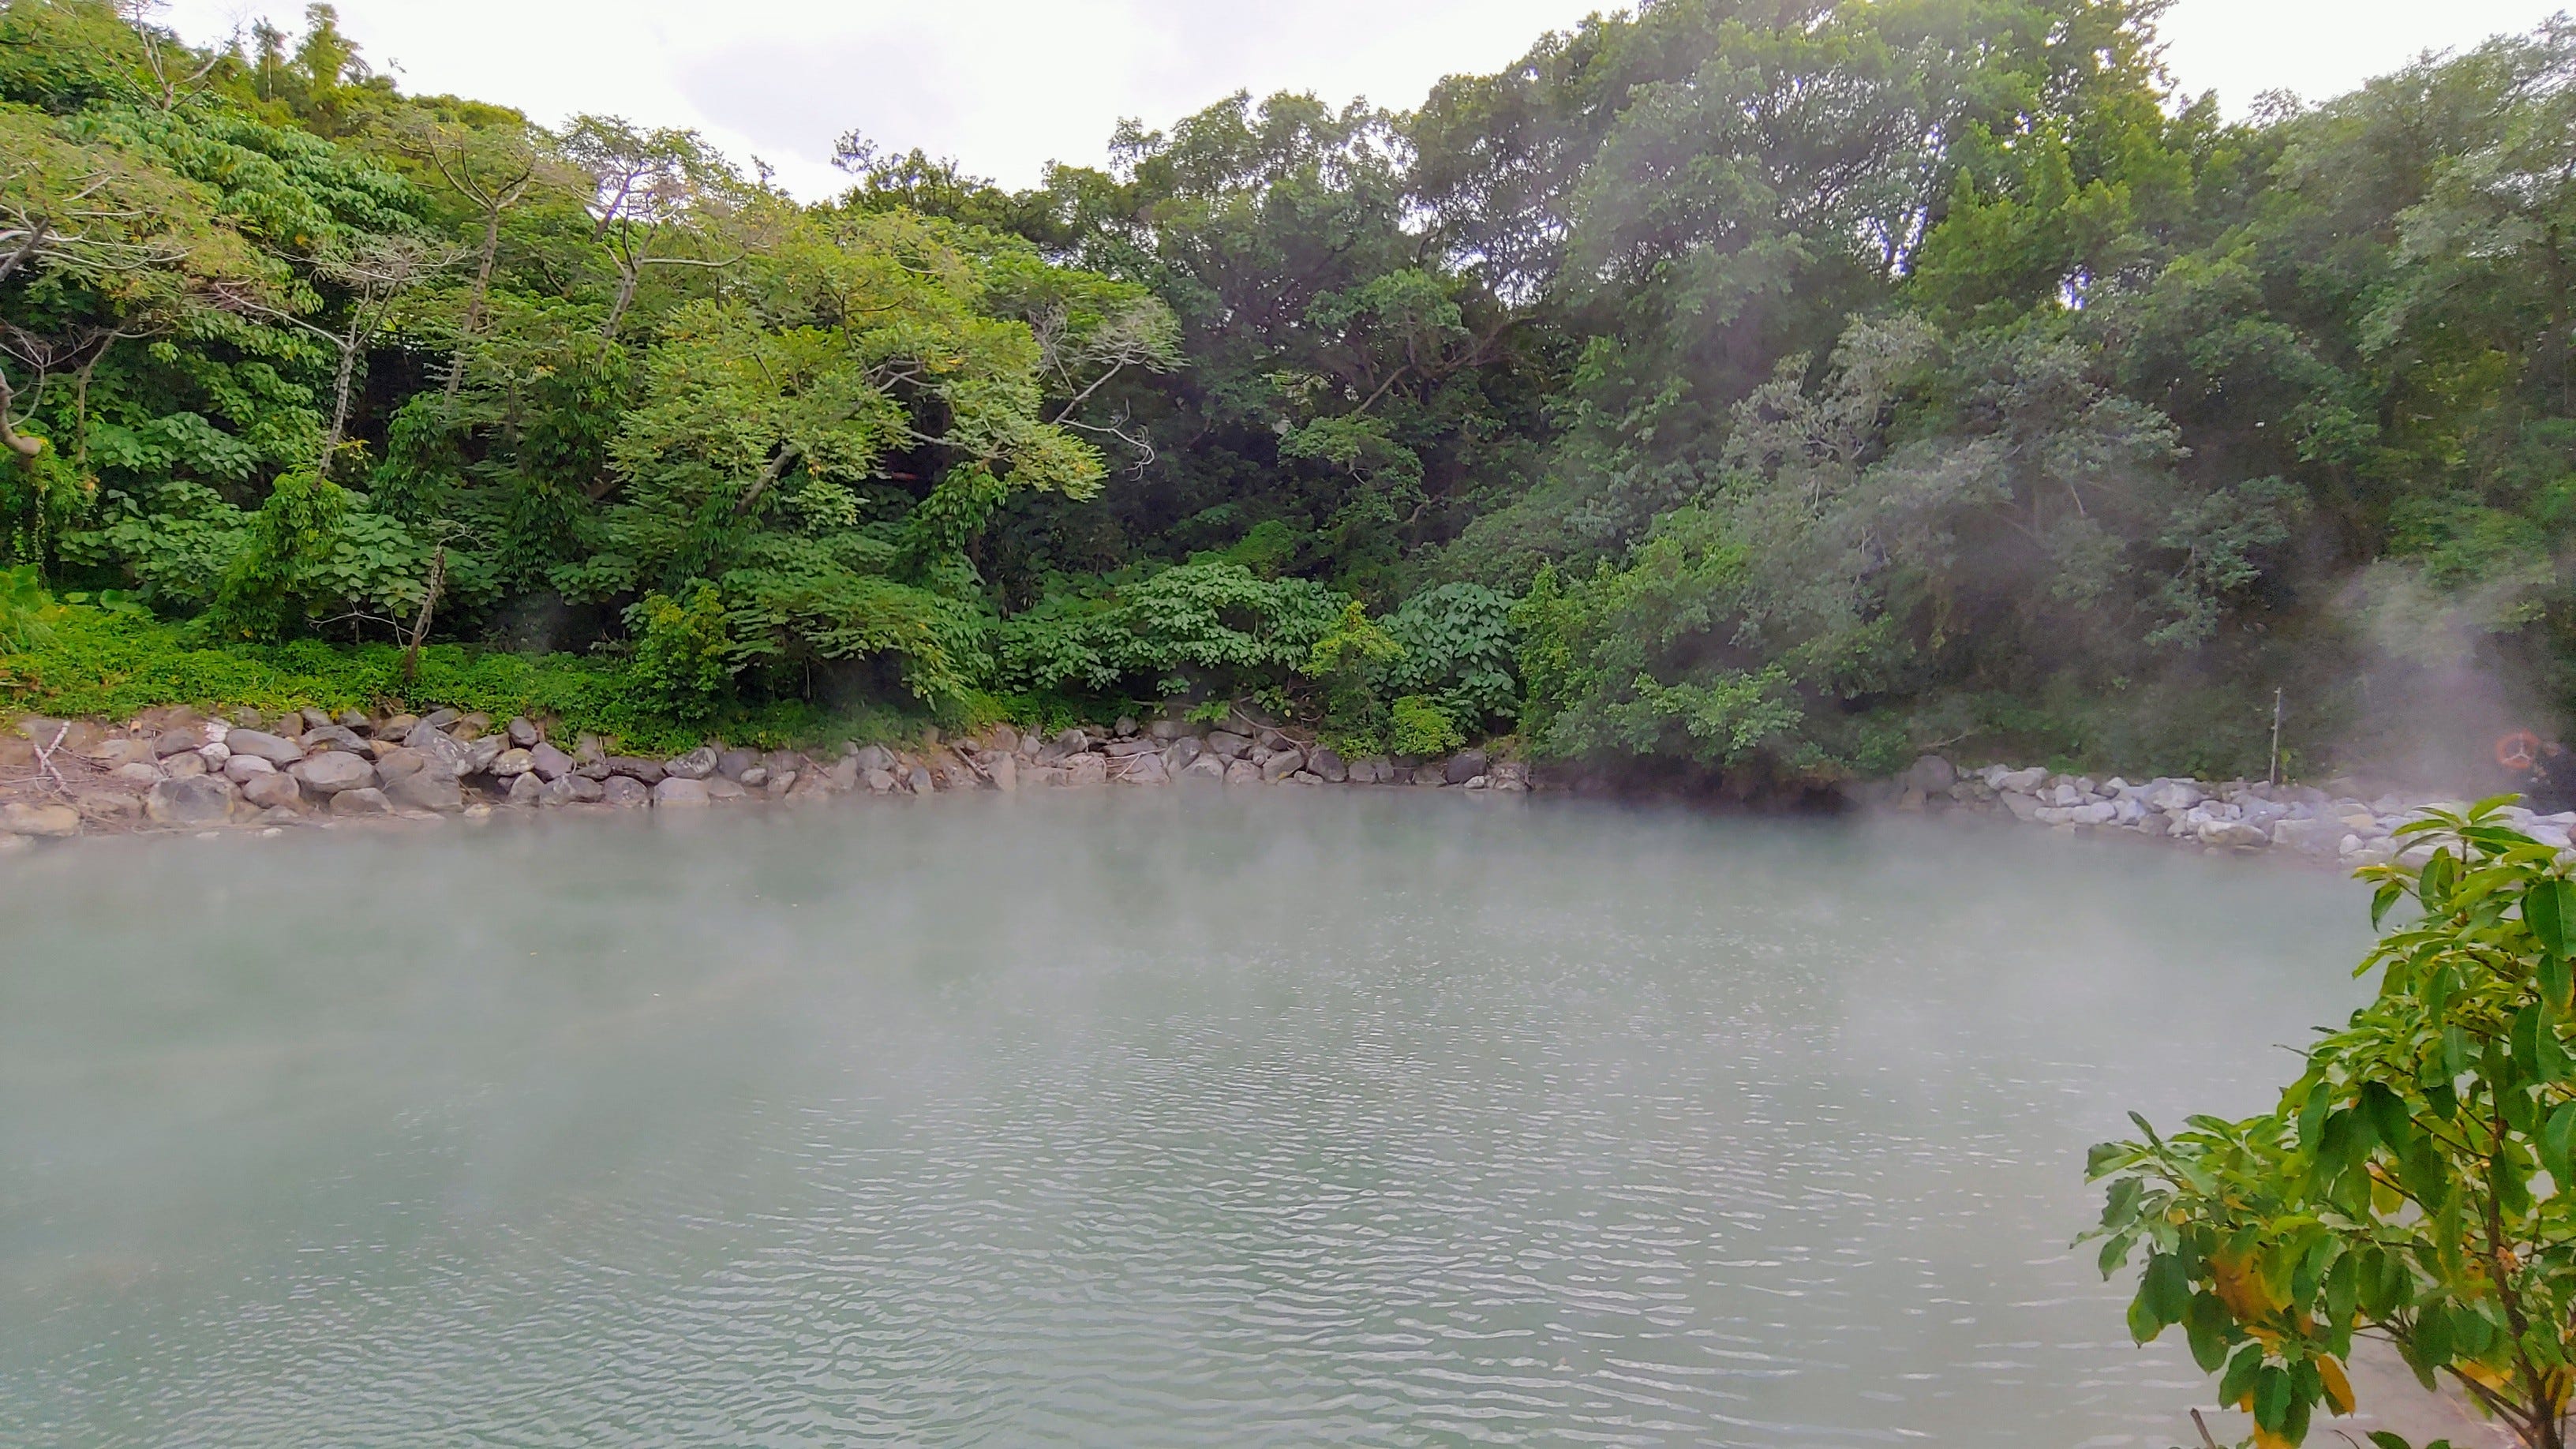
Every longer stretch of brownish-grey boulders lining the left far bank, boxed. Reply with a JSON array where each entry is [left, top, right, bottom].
[[0, 709, 1530, 848]]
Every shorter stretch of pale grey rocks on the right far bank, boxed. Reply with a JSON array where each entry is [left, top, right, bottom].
[[1855, 755, 2534, 869]]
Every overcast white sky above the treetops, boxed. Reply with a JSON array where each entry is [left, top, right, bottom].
[[167, 0, 2568, 196]]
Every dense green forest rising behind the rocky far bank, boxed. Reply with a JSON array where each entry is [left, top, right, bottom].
[[0, 0, 2576, 784]]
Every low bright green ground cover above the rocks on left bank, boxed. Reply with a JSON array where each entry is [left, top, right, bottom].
[[0, 606, 923, 753]]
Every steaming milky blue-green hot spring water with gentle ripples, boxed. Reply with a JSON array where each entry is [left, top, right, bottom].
[[0, 792, 2368, 1449]]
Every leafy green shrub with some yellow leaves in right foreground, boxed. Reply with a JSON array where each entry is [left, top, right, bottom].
[[2089, 799, 2576, 1447]]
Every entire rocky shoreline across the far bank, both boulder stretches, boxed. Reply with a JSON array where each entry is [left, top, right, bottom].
[[0, 709, 2514, 867]]
